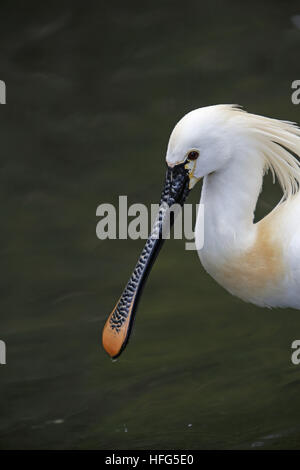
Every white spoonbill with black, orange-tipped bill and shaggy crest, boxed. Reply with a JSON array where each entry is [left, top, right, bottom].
[[103, 105, 300, 357]]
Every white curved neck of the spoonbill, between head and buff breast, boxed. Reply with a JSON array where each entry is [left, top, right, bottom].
[[196, 152, 264, 256]]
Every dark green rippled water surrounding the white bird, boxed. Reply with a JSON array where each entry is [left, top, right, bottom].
[[0, 0, 300, 449]]
